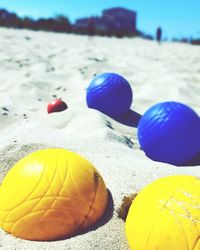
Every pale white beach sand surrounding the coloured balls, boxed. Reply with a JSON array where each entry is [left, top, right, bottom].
[[0, 29, 200, 250]]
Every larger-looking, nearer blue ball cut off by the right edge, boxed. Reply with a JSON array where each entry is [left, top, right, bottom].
[[138, 102, 200, 166]]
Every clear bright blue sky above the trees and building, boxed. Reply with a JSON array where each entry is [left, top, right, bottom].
[[0, 0, 200, 38]]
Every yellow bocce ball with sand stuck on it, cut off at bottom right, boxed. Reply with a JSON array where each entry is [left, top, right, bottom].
[[126, 176, 200, 250]]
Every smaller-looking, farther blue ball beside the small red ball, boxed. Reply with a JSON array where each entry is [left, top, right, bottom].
[[86, 73, 132, 117]]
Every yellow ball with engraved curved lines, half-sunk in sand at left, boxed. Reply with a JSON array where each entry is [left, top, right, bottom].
[[0, 148, 108, 240]]
